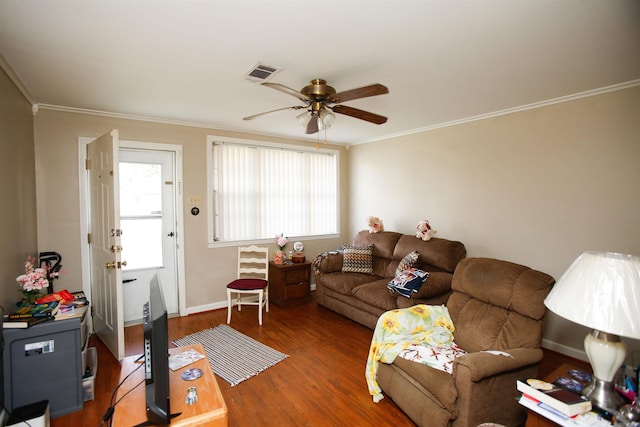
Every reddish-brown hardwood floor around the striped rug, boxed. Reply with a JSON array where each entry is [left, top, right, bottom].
[[51, 302, 585, 427]]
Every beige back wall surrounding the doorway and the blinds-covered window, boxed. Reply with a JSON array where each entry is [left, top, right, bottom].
[[35, 110, 348, 311]]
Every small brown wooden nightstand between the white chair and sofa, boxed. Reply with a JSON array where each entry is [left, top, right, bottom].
[[269, 261, 311, 307]]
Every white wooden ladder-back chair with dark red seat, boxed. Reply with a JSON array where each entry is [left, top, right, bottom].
[[227, 245, 269, 325]]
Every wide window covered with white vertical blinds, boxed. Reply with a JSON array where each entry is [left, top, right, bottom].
[[209, 137, 338, 243]]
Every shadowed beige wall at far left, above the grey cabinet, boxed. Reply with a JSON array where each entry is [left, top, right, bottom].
[[0, 68, 38, 311]]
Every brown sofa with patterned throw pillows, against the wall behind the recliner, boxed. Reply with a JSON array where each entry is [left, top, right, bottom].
[[313, 230, 466, 329]]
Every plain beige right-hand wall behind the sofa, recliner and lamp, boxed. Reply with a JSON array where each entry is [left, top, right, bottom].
[[349, 87, 640, 362]]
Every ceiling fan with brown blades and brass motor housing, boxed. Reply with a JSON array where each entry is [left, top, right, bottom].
[[243, 79, 389, 134]]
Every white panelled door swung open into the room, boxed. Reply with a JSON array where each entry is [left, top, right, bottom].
[[87, 129, 124, 360]]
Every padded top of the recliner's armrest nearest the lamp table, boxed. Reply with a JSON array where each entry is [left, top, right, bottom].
[[453, 348, 543, 381]]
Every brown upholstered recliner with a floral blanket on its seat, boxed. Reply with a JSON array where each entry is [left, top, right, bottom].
[[378, 258, 555, 427]]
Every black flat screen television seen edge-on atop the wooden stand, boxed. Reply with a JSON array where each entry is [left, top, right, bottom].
[[142, 274, 171, 425]]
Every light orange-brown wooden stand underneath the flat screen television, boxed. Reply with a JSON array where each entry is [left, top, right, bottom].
[[113, 344, 229, 427]]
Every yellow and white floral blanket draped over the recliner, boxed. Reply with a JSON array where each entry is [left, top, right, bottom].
[[365, 305, 464, 403]]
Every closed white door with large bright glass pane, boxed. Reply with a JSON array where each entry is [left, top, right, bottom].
[[120, 149, 179, 324]]
